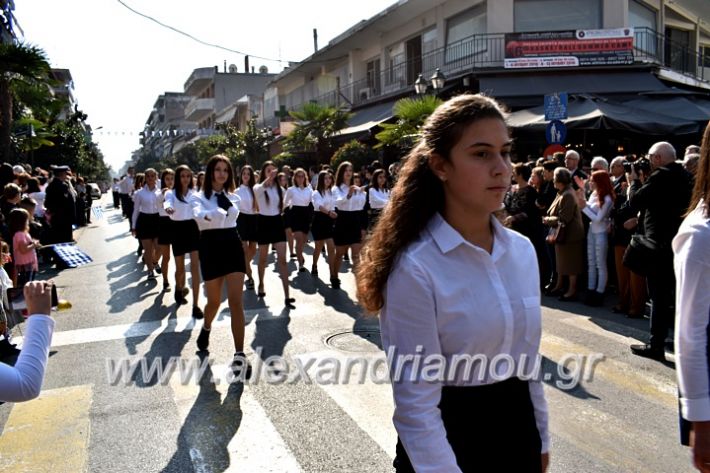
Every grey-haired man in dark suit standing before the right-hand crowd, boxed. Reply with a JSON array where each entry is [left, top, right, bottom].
[[627, 142, 692, 360]]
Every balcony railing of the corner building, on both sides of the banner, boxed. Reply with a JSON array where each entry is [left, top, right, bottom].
[[284, 28, 710, 110]]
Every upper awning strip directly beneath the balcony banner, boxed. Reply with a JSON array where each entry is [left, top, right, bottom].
[[479, 71, 668, 98]]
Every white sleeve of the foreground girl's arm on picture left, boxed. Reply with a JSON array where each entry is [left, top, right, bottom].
[[380, 260, 461, 473]]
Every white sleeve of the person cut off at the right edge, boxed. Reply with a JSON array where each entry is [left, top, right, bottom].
[[675, 249, 710, 422]]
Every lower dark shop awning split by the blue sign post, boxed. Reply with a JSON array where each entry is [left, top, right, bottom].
[[508, 96, 699, 135]]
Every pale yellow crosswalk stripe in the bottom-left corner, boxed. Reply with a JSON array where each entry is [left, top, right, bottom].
[[0, 385, 93, 473]]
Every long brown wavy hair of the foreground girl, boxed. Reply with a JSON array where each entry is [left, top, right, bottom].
[[355, 94, 505, 314]]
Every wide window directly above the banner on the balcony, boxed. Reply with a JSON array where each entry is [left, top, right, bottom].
[[513, 0, 602, 33]]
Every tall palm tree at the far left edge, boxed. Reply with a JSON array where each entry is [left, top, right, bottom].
[[0, 43, 51, 161]]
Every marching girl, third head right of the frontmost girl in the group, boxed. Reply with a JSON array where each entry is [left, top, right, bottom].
[[284, 168, 313, 271]]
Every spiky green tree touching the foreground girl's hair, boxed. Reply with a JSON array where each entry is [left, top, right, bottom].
[[375, 95, 443, 154]]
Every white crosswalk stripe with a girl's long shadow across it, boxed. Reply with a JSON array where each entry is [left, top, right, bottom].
[[170, 365, 301, 473]]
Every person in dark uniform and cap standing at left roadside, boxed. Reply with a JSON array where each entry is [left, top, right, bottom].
[[44, 166, 76, 243]]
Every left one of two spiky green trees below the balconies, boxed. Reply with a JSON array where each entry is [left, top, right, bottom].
[[284, 103, 352, 163]]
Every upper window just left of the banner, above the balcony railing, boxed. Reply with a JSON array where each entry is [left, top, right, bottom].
[[446, 2, 488, 63]]
